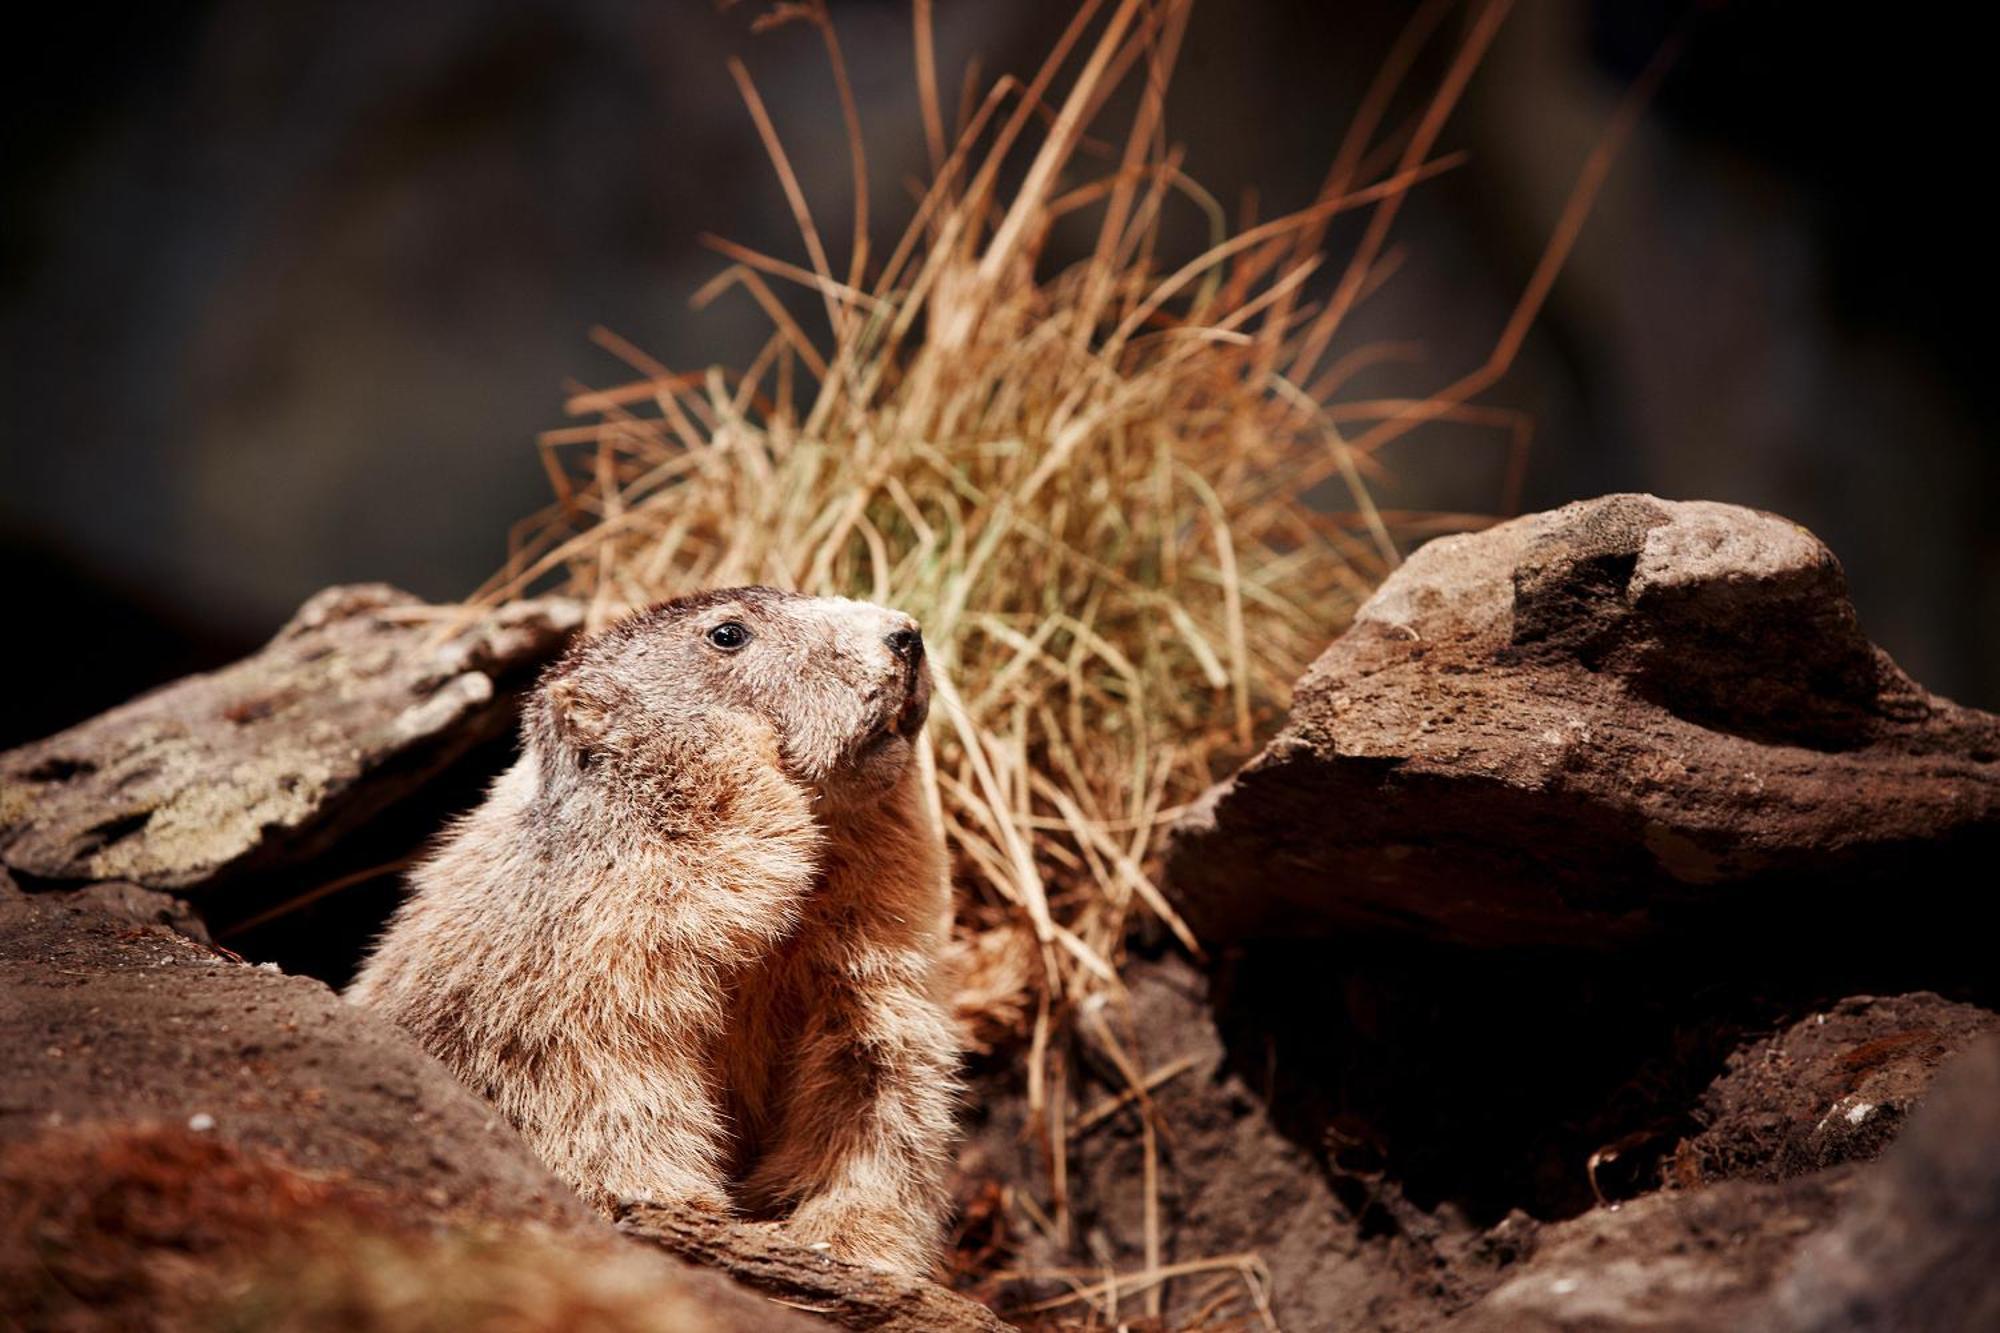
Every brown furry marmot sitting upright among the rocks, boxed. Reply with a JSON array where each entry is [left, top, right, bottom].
[[348, 588, 958, 1273]]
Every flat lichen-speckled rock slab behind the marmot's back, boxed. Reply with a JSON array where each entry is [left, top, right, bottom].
[[0, 584, 582, 891]]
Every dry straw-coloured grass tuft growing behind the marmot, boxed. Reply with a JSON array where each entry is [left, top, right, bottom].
[[482, 0, 1648, 1304]]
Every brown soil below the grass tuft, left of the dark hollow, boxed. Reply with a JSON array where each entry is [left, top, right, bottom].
[[962, 957, 1534, 1329]]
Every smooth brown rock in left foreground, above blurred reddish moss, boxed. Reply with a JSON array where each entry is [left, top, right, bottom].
[[0, 872, 594, 1227]]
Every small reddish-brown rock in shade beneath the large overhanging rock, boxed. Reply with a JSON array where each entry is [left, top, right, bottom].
[[1672, 993, 2000, 1187]]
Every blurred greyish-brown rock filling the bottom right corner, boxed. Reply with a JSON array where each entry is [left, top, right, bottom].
[[1768, 1037, 2000, 1333]]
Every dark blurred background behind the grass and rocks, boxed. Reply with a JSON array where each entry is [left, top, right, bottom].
[[0, 0, 2000, 745]]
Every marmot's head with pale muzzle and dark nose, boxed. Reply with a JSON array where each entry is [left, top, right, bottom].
[[530, 586, 930, 807]]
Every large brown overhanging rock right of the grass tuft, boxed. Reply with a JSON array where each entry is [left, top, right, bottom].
[[1168, 494, 2000, 945]]
